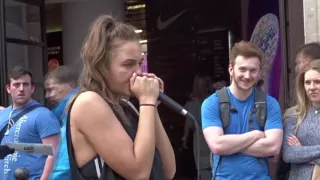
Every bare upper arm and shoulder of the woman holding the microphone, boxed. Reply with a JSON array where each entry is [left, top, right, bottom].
[[70, 92, 139, 173]]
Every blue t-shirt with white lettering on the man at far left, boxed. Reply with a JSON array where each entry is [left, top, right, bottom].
[[0, 101, 60, 180]]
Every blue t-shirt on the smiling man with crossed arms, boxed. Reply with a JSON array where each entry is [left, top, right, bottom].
[[201, 88, 282, 180]]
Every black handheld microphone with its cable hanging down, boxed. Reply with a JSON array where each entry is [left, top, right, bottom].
[[158, 92, 201, 180]]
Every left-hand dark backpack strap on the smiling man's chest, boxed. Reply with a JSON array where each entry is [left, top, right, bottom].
[[217, 87, 231, 129]]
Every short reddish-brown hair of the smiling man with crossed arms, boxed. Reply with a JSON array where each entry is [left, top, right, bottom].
[[230, 41, 263, 67]]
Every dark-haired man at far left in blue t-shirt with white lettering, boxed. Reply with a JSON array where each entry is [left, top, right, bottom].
[[0, 67, 60, 180]]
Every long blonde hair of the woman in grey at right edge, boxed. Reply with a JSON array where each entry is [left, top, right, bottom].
[[284, 59, 320, 132]]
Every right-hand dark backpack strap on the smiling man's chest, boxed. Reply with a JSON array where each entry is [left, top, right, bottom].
[[254, 88, 267, 131]]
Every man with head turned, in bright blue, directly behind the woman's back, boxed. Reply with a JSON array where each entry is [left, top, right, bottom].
[[45, 66, 79, 180]]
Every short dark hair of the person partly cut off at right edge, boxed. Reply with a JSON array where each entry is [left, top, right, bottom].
[[297, 42, 320, 61]]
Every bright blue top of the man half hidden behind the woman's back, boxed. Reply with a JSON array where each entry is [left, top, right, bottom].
[[50, 88, 79, 180]]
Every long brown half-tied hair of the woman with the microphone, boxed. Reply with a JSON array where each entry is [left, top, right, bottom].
[[70, 15, 139, 123]]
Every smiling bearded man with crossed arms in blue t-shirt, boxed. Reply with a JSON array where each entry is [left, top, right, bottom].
[[201, 41, 283, 180]]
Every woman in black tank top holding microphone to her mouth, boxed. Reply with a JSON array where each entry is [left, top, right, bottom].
[[67, 15, 176, 180]]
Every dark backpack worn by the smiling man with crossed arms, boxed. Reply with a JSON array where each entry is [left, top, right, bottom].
[[210, 87, 267, 179]]
